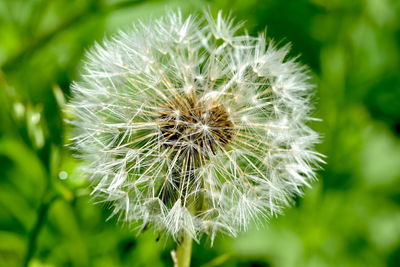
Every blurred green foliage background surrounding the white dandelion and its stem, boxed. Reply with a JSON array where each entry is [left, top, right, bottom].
[[0, 0, 400, 267]]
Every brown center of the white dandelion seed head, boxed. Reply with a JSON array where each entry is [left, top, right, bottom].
[[159, 94, 234, 158]]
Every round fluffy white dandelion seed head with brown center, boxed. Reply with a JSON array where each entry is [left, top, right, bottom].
[[69, 9, 322, 266]]
